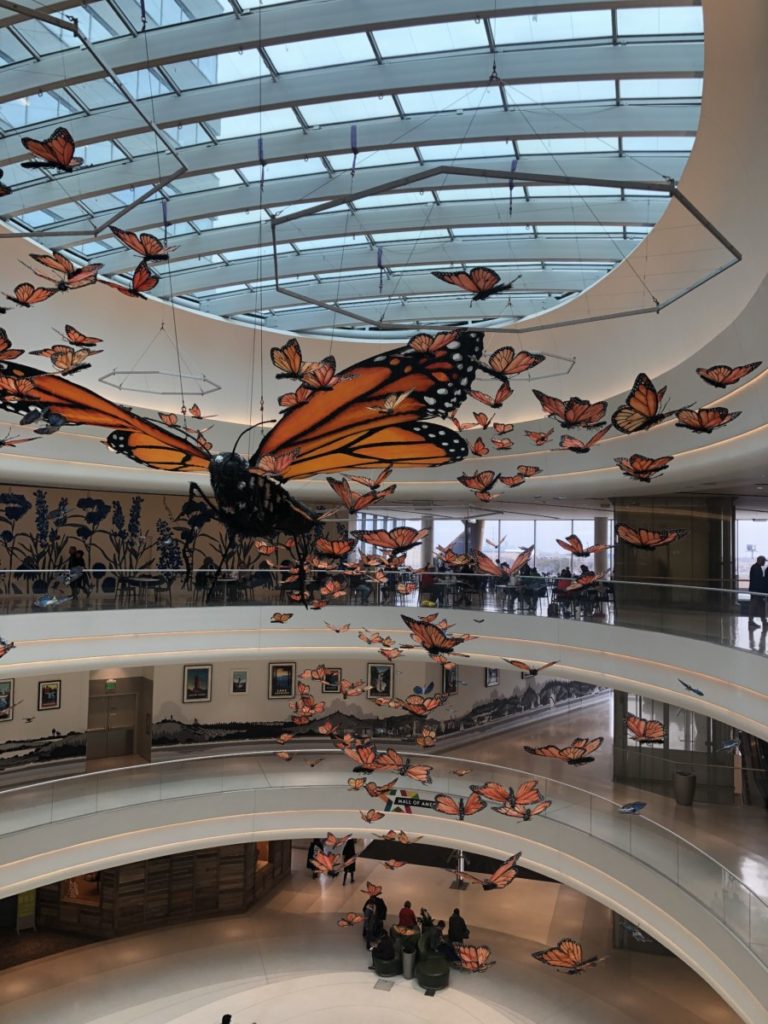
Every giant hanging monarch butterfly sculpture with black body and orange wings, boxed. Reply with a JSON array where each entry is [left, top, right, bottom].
[[0, 329, 482, 552]]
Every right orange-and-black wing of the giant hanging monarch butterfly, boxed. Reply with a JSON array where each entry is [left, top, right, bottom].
[[252, 332, 482, 479]]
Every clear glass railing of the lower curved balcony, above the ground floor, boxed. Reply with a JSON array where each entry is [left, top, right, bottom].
[[0, 746, 768, 967]]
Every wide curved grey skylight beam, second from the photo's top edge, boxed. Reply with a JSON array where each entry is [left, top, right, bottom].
[[0, 41, 703, 163]]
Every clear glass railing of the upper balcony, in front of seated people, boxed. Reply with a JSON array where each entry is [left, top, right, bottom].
[[0, 568, 768, 654]]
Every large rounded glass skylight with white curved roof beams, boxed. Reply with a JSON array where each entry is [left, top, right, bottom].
[[0, 0, 703, 332]]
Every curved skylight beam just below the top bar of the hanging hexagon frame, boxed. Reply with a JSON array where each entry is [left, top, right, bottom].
[[124, 197, 668, 264]]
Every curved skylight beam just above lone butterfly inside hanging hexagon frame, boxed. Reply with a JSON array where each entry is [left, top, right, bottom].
[[151, 236, 637, 298]]
